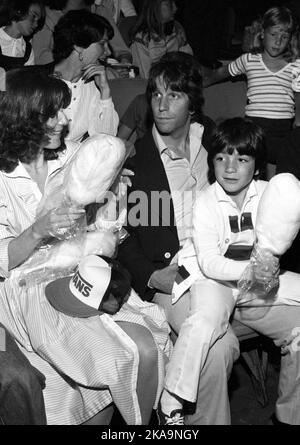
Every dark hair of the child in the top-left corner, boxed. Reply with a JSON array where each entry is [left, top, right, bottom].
[[0, 0, 45, 28]]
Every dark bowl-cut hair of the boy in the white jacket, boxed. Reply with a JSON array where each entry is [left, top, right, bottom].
[[207, 117, 267, 184]]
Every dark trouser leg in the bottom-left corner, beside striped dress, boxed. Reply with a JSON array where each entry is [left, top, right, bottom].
[[0, 324, 46, 425]]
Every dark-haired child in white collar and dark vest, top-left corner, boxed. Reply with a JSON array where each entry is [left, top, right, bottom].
[[0, 0, 44, 71]]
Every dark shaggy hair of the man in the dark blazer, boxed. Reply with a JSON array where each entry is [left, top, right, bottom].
[[147, 51, 204, 122]]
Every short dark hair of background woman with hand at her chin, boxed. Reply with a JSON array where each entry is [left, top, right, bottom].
[[53, 9, 114, 63]]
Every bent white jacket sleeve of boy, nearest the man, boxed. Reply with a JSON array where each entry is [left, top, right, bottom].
[[193, 192, 249, 281]]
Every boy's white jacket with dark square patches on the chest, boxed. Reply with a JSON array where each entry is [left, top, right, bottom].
[[193, 180, 267, 281]]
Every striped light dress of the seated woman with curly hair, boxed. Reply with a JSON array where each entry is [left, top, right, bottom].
[[0, 142, 171, 425]]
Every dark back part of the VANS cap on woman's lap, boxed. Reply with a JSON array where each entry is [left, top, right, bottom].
[[99, 255, 131, 308]]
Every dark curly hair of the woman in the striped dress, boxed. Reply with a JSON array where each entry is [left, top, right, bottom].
[[0, 67, 71, 173]]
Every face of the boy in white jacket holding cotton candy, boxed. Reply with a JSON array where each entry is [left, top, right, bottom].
[[213, 150, 256, 207]]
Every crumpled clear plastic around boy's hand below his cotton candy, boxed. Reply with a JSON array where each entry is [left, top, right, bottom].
[[237, 245, 279, 319]]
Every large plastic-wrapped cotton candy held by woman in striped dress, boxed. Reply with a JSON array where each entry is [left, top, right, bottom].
[[11, 135, 127, 285]]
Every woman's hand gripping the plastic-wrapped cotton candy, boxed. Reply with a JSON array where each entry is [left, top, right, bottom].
[[31, 207, 85, 240]]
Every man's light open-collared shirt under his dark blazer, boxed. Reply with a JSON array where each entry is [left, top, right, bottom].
[[153, 123, 208, 246]]
